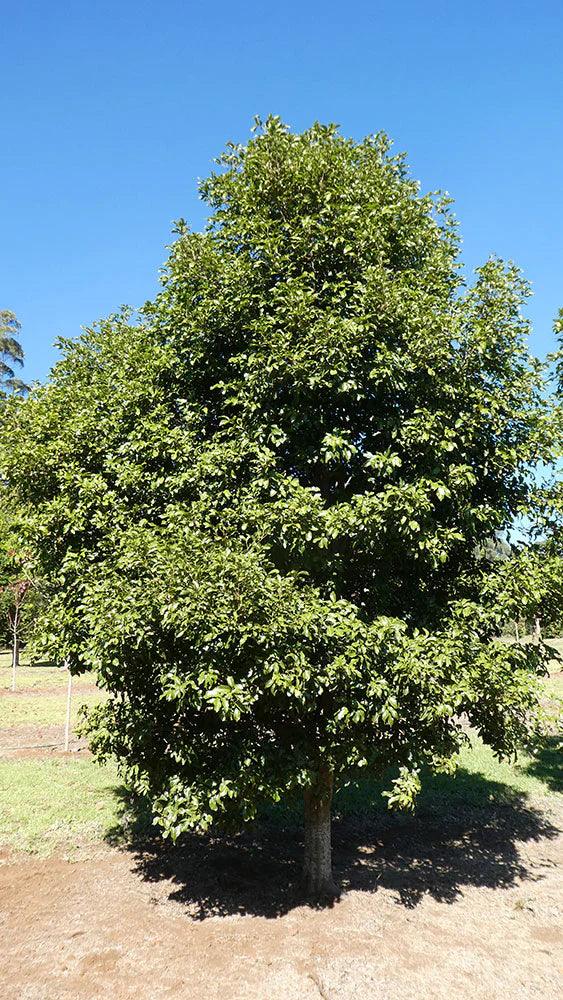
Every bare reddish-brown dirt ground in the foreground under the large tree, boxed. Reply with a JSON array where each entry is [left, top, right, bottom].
[[0, 801, 563, 1000]]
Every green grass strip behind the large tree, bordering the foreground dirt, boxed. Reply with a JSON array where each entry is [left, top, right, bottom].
[[0, 740, 563, 855]]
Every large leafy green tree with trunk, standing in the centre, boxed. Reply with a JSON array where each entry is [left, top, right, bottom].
[[2, 118, 552, 897]]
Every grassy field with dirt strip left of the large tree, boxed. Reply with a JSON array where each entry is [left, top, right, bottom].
[[0, 651, 114, 855]]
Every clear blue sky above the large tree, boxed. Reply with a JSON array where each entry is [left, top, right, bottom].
[[0, 0, 563, 379]]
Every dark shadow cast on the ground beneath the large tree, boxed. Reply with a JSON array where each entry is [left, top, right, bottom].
[[109, 772, 559, 920]]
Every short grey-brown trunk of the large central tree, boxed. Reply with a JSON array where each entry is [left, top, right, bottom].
[[303, 767, 340, 901]]
